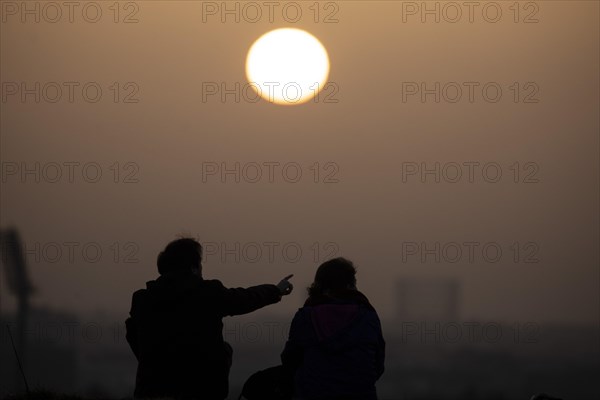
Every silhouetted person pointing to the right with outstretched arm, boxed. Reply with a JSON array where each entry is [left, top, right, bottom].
[[125, 238, 293, 400]]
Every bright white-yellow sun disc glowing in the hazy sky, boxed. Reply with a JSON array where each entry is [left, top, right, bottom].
[[246, 28, 329, 105]]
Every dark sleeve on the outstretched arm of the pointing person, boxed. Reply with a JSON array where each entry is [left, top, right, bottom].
[[219, 282, 281, 316]]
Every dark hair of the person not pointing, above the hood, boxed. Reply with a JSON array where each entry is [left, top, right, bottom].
[[308, 257, 356, 297]]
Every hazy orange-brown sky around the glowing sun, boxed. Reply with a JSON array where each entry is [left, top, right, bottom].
[[0, 1, 600, 324]]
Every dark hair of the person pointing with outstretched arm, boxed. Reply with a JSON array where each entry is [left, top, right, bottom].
[[156, 238, 202, 275]]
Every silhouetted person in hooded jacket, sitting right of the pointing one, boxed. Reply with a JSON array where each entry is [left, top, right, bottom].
[[281, 258, 385, 400]]
